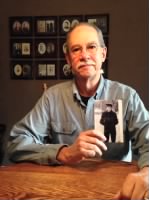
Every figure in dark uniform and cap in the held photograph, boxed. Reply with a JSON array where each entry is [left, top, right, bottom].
[[100, 104, 118, 142]]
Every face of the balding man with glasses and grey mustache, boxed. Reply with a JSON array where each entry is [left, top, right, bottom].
[[66, 25, 107, 79]]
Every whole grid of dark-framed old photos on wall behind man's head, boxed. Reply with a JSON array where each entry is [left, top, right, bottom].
[[9, 14, 109, 80]]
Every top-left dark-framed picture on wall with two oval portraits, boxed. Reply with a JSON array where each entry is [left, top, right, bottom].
[[9, 16, 33, 37]]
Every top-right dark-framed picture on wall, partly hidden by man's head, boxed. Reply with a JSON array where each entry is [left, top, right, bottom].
[[85, 14, 109, 34]]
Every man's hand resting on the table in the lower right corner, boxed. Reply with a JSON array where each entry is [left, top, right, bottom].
[[113, 167, 149, 200]]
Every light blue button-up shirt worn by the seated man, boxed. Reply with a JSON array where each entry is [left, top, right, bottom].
[[8, 77, 149, 167]]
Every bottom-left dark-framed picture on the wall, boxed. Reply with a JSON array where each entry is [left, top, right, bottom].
[[10, 61, 33, 79]]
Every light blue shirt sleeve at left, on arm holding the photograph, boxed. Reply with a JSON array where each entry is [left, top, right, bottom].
[[7, 92, 64, 165]]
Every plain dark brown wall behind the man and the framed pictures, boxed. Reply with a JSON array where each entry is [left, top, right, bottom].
[[0, 0, 149, 133]]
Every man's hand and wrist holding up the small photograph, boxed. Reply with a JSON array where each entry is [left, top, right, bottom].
[[57, 130, 107, 164]]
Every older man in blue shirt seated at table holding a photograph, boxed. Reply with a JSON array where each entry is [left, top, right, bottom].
[[8, 23, 149, 200]]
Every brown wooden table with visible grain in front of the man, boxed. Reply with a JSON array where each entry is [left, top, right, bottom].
[[0, 160, 137, 200]]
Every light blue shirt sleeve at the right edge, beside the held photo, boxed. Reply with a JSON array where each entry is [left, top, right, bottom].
[[128, 93, 149, 168]]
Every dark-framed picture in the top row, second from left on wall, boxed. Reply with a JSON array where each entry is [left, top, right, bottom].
[[34, 16, 58, 36]]
